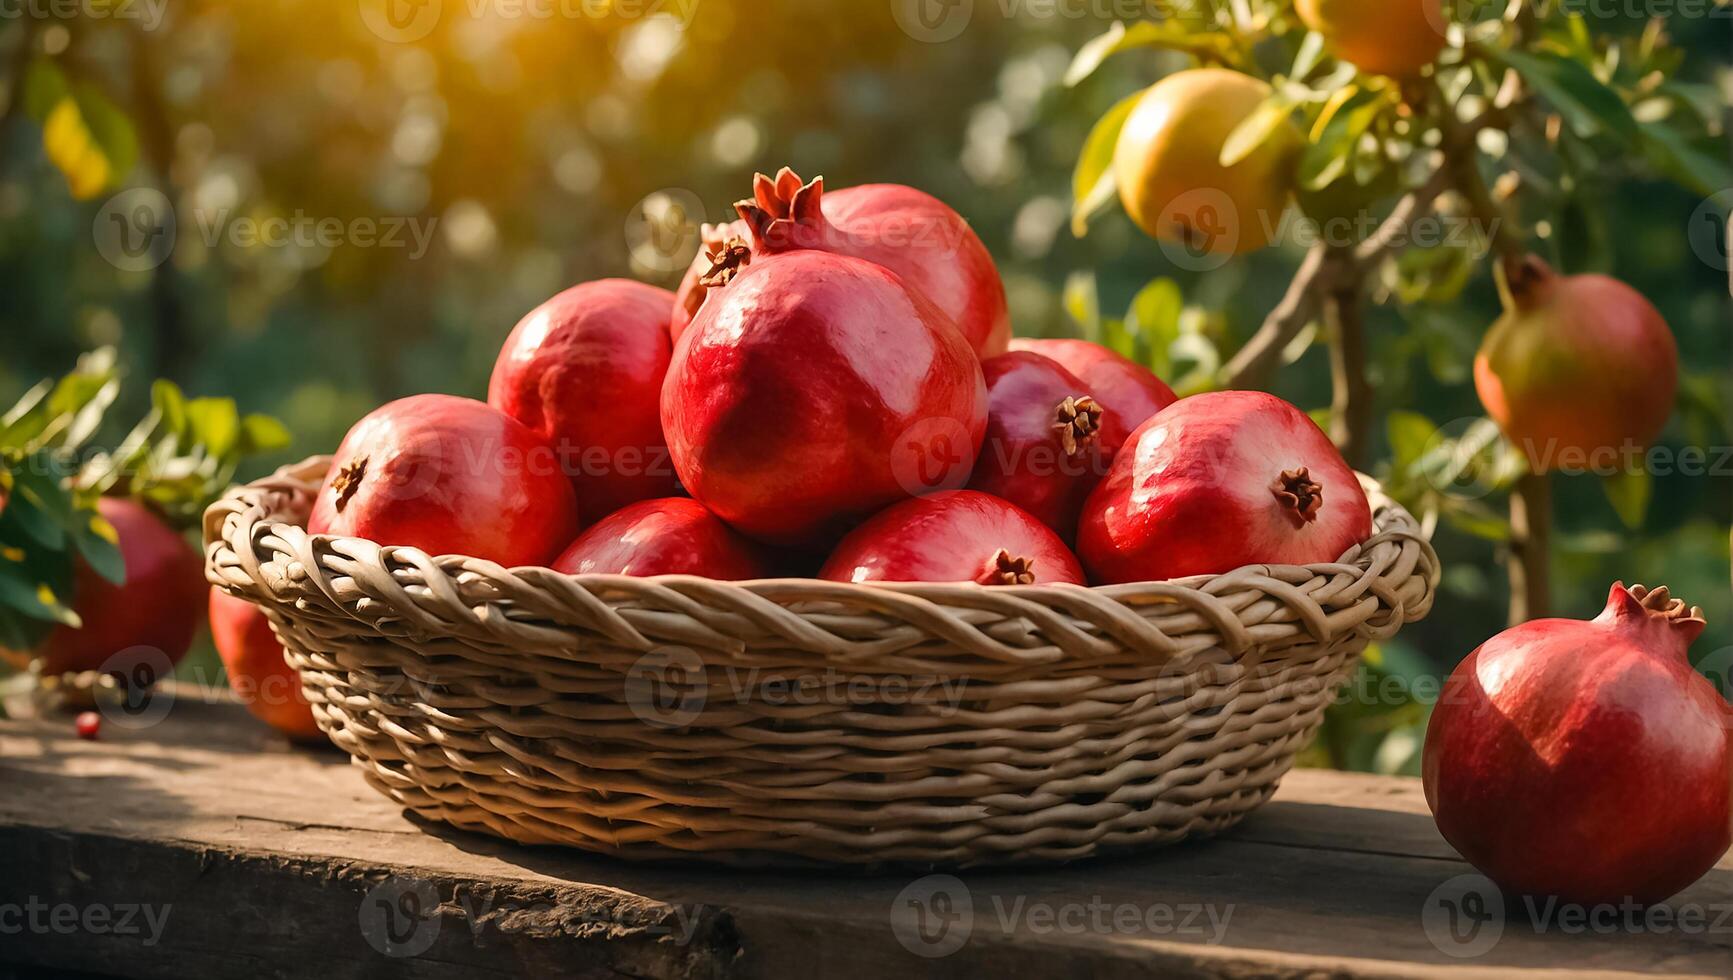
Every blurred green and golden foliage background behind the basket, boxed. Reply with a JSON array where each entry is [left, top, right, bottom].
[[0, 0, 1733, 770]]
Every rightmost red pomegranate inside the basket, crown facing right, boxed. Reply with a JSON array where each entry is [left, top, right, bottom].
[[1078, 392, 1373, 585]]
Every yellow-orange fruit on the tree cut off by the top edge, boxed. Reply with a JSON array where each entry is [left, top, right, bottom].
[[1295, 0, 1449, 78]]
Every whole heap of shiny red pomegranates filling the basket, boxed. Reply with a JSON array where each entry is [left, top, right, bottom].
[[308, 170, 1371, 586]]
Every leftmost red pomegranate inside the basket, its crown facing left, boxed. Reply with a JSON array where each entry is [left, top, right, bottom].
[[307, 395, 579, 567]]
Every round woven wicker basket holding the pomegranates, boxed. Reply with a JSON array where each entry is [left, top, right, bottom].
[[204, 458, 1438, 866]]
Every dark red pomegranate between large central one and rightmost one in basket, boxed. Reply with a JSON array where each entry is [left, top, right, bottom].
[[969, 350, 1130, 539]]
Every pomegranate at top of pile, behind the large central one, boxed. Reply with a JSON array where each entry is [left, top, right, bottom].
[[717, 167, 1010, 357]]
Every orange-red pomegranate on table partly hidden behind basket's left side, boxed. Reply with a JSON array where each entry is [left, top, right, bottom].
[[210, 588, 324, 742]]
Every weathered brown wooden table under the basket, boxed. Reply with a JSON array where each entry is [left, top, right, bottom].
[[0, 689, 1733, 980]]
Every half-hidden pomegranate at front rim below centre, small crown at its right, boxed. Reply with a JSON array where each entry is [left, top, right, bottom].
[[818, 491, 1085, 585]]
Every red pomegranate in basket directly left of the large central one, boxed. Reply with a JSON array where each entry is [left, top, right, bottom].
[[487, 279, 676, 517]]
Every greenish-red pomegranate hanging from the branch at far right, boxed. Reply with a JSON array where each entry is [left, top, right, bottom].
[[1475, 257, 1679, 474]]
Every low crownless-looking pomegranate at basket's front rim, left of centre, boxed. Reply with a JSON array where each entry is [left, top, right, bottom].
[[553, 496, 775, 581]]
